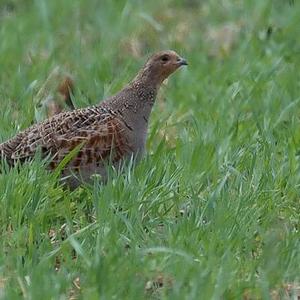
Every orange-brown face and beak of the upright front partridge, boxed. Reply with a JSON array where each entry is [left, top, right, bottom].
[[145, 50, 187, 83]]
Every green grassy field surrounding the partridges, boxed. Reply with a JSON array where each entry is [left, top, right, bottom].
[[0, 0, 300, 300]]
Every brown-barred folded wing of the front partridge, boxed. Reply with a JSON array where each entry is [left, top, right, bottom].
[[0, 107, 130, 168]]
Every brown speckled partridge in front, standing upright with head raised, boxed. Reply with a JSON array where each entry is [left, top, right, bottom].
[[0, 50, 188, 189]]
